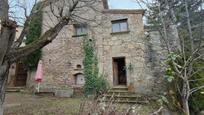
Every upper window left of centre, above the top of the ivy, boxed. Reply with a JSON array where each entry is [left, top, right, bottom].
[[74, 24, 87, 36]]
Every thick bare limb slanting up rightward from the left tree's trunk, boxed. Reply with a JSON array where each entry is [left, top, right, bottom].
[[6, 0, 78, 63]]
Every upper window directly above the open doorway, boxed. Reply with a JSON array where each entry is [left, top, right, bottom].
[[112, 19, 128, 33]]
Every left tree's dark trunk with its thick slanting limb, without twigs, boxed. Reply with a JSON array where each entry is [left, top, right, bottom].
[[0, 0, 79, 115]]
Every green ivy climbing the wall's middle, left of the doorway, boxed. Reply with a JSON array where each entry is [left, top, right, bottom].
[[83, 39, 108, 96]]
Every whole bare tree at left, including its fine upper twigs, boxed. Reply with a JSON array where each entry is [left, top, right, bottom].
[[0, 0, 102, 115]]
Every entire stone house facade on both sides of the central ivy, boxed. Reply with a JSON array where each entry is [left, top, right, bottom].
[[38, 0, 166, 94]]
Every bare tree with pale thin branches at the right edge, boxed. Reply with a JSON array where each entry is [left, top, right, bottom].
[[137, 0, 204, 115]]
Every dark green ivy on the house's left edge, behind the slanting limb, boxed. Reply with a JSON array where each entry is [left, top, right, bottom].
[[22, 3, 42, 70]]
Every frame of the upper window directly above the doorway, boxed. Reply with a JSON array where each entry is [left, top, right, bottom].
[[111, 18, 129, 33]]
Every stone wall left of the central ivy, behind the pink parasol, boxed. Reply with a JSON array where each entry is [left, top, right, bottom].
[[39, 1, 102, 90]]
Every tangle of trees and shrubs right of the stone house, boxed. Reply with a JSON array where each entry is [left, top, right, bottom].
[[143, 0, 204, 115]]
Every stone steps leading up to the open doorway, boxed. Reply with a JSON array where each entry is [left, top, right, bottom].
[[104, 86, 149, 104]]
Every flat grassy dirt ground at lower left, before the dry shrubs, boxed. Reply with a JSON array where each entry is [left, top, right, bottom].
[[4, 93, 82, 115]]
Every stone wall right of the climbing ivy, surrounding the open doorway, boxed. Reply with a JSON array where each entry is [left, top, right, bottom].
[[95, 13, 167, 94]]
